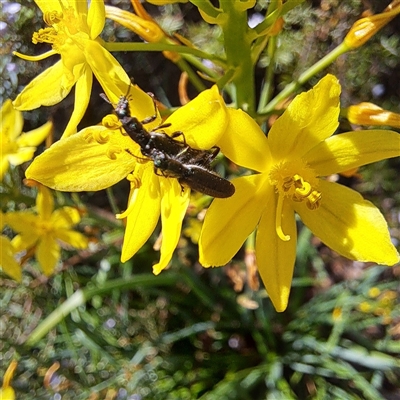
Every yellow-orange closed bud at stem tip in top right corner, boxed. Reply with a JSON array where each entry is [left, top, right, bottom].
[[344, 0, 400, 49]]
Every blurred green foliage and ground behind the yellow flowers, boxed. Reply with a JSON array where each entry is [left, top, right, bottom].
[[0, 0, 400, 400]]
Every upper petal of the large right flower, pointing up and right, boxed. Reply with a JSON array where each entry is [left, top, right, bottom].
[[268, 75, 340, 160]]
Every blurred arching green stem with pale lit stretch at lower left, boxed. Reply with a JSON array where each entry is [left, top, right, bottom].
[[25, 273, 178, 347]]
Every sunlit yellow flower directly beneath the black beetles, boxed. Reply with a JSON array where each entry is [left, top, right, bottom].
[[26, 86, 227, 274]]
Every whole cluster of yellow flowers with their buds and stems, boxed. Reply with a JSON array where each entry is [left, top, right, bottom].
[[2, 0, 400, 311]]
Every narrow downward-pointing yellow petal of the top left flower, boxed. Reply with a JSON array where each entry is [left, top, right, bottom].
[[63, 66, 93, 138]]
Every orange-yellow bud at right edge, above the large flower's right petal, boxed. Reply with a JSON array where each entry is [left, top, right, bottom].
[[347, 103, 400, 128]]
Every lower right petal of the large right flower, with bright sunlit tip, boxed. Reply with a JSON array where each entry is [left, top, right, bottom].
[[293, 180, 399, 265]]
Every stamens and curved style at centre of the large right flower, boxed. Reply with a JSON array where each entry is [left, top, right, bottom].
[[269, 159, 322, 241]]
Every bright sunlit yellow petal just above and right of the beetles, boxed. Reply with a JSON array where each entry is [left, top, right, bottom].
[[165, 85, 228, 150]]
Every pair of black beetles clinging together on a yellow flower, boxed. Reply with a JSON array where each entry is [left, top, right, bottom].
[[111, 96, 235, 198]]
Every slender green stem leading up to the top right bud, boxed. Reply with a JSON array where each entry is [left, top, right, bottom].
[[260, 43, 351, 114]]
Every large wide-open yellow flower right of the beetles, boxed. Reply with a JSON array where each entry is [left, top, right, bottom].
[[199, 75, 400, 311]]
